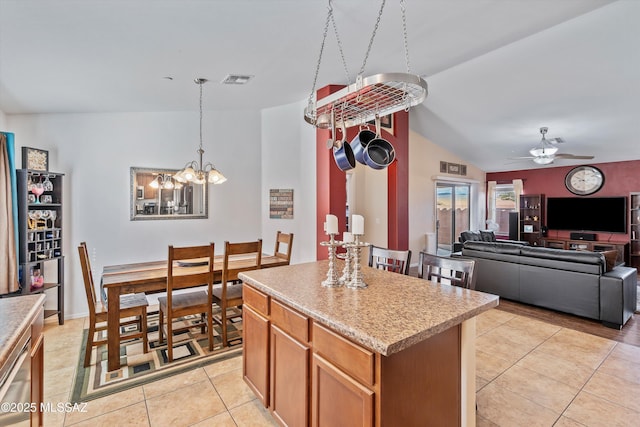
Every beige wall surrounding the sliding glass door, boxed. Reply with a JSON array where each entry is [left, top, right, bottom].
[[409, 130, 486, 264]]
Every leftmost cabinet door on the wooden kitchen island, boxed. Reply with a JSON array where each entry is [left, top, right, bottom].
[[242, 305, 269, 408]]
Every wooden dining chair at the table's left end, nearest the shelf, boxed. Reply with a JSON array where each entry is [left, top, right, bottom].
[[78, 242, 149, 368]]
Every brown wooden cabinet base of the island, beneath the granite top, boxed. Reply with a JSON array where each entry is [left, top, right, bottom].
[[243, 283, 463, 427]]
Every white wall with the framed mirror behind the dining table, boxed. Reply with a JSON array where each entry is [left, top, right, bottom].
[[6, 111, 263, 318]]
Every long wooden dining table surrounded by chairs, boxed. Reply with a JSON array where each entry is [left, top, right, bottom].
[[101, 254, 289, 371]]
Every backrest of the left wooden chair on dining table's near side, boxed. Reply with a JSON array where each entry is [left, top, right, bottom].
[[167, 243, 215, 294]]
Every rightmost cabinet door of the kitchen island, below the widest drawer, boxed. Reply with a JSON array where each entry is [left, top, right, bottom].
[[311, 354, 374, 427]]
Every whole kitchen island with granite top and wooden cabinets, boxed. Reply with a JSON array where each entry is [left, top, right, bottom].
[[240, 261, 498, 426]]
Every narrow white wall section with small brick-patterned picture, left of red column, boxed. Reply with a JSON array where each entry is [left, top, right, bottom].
[[261, 102, 316, 264]]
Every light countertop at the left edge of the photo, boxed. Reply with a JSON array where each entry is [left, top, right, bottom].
[[0, 294, 45, 367]]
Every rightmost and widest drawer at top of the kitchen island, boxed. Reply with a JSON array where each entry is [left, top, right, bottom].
[[312, 322, 375, 386]]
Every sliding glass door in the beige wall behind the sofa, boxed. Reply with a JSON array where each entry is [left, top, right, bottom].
[[436, 183, 471, 255]]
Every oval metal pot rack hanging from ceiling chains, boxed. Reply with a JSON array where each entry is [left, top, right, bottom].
[[304, 0, 428, 129]]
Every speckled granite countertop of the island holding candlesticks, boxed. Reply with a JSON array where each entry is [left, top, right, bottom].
[[239, 261, 498, 356]]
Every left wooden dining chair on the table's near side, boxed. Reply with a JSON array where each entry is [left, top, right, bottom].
[[158, 243, 215, 362]]
